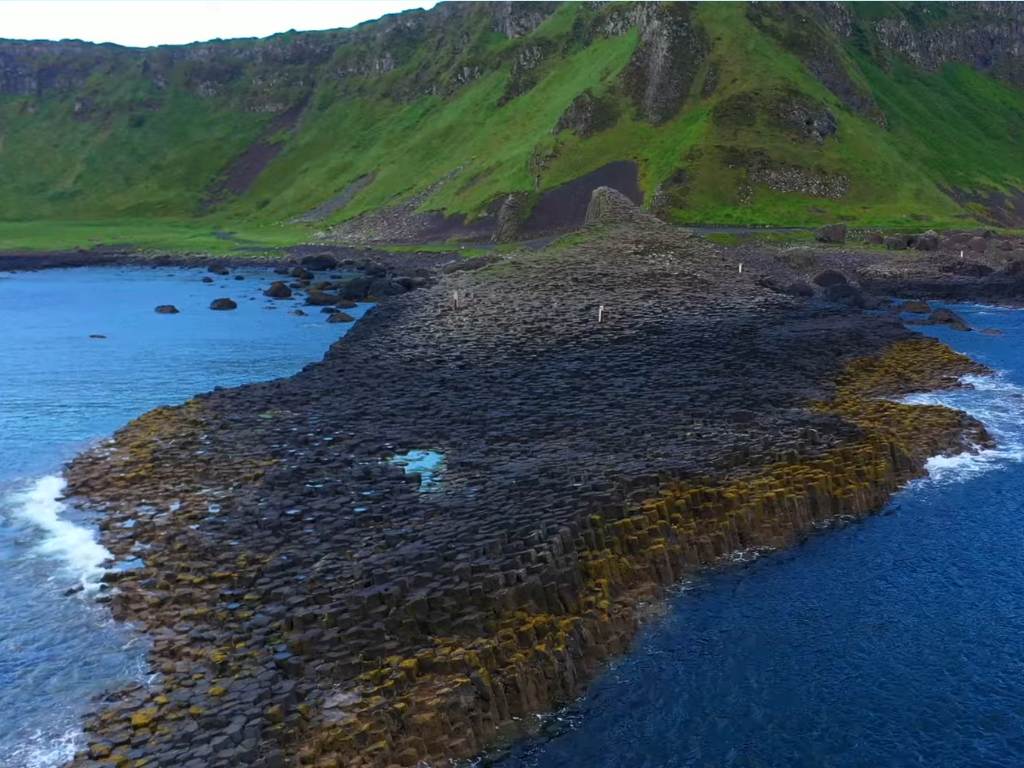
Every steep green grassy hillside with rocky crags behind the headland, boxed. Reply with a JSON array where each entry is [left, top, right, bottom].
[[0, 3, 1024, 250]]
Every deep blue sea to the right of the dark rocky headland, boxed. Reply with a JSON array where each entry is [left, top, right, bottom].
[[493, 306, 1024, 768]]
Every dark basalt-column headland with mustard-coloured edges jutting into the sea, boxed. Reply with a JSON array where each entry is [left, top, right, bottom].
[[61, 199, 1024, 768]]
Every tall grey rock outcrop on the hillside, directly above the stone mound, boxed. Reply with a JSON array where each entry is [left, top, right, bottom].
[[623, 3, 711, 123]]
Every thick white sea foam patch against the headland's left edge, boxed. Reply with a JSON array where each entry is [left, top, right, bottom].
[[10, 475, 111, 590]]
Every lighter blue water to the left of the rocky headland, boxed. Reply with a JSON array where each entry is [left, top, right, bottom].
[[0, 267, 367, 768]]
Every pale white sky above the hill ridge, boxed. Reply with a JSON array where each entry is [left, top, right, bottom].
[[0, 0, 436, 46]]
